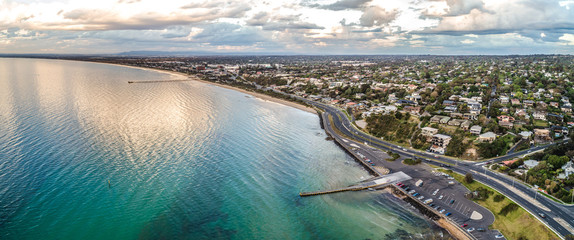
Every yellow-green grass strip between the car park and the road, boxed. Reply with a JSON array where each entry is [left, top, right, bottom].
[[439, 169, 558, 240]]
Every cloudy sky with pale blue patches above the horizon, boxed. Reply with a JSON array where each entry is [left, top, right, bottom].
[[0, 0, 574, 55]]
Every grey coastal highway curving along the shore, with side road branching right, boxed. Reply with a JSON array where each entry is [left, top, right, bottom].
[[306, 98, 574, 238]]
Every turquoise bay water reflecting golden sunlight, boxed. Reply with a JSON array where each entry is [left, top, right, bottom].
[[0, 58, 440, 239]]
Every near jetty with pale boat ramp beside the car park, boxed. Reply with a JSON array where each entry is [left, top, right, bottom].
[[299, 172, 412, 197]]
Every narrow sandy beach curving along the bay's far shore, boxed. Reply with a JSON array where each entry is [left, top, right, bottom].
[[108, 62, 317, 114]]
